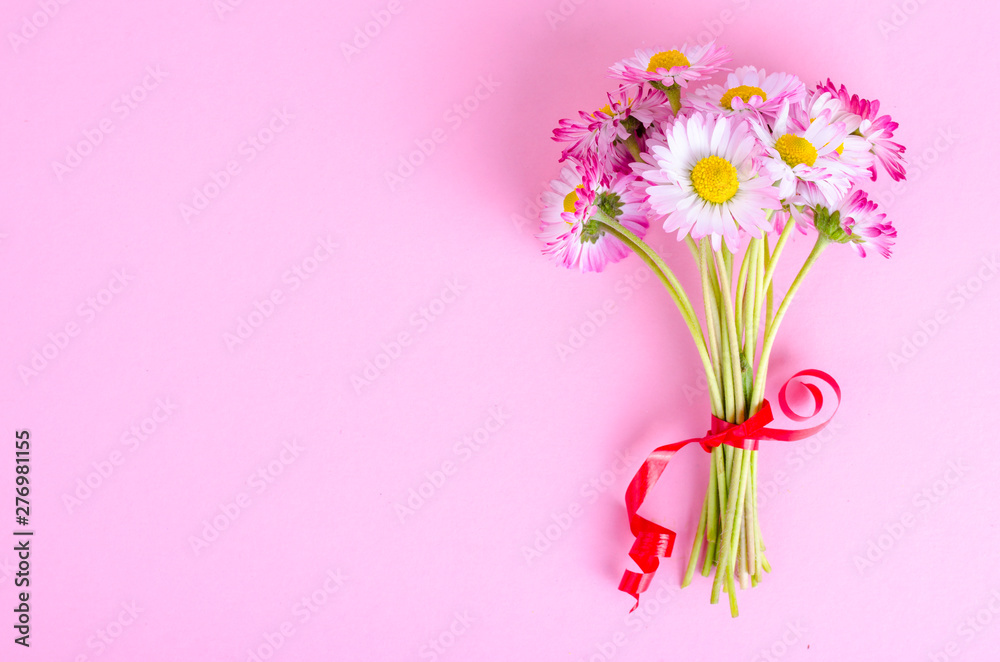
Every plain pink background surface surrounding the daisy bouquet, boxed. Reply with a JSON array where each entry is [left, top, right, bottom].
[[0, 0, 1000, 662]]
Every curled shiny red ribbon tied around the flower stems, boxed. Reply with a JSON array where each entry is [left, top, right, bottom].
[[618, 370, 840, 613]]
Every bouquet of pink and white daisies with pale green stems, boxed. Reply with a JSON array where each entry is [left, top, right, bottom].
[[538, 44, 905, 616]]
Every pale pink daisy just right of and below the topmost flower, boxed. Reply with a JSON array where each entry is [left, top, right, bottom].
[[690, 67, 806, 119]]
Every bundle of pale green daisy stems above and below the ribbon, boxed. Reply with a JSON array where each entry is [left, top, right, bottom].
[[596, 211, 829, 617]]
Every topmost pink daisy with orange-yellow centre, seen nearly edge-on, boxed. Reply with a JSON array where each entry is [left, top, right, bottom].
[[611, 42, 732, 88]]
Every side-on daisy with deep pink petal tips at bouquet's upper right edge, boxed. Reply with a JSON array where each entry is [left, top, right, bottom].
[[811, 79, 906, 181]]
